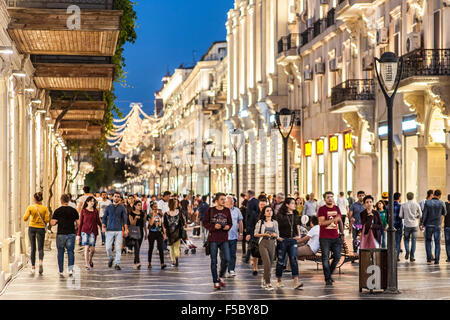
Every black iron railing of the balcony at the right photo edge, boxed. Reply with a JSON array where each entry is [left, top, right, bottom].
[[402, 49, 450, 80]]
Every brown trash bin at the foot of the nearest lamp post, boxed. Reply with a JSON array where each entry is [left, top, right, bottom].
[[359, 249, 388, 293]]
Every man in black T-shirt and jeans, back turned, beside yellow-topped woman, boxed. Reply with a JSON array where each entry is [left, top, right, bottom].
[[50, 194, 80, 277]]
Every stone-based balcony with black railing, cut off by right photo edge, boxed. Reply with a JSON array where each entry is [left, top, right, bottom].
[[399, 49, 450, 91]]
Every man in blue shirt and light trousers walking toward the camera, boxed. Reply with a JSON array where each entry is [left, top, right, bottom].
[[102, 192, 128, 270]]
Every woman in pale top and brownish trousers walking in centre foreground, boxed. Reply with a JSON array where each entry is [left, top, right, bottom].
[[255, 206, 279, 291]]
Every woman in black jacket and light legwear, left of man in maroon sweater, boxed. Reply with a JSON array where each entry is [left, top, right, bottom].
[[164, 199, 185, 267]]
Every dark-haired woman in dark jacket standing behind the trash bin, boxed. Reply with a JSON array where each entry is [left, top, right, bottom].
[[360, 195, 383, 249]]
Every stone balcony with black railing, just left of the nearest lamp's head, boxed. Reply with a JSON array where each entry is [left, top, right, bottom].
[[331, 79, 375, 112]]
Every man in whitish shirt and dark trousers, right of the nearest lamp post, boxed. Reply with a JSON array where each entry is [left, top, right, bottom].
[[400, 192, 422, 262]]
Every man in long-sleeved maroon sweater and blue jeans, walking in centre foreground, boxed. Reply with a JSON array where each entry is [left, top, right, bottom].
[[203, 192, 233, 289]]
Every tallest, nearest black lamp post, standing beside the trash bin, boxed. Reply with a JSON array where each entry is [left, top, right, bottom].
[[375, 52, 403, 293]]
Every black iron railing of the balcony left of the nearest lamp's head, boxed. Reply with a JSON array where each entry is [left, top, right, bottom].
[[331, 79, 375, 106]]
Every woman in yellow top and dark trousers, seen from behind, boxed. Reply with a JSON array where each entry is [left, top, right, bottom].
[[23, 192, 50, 274]]
